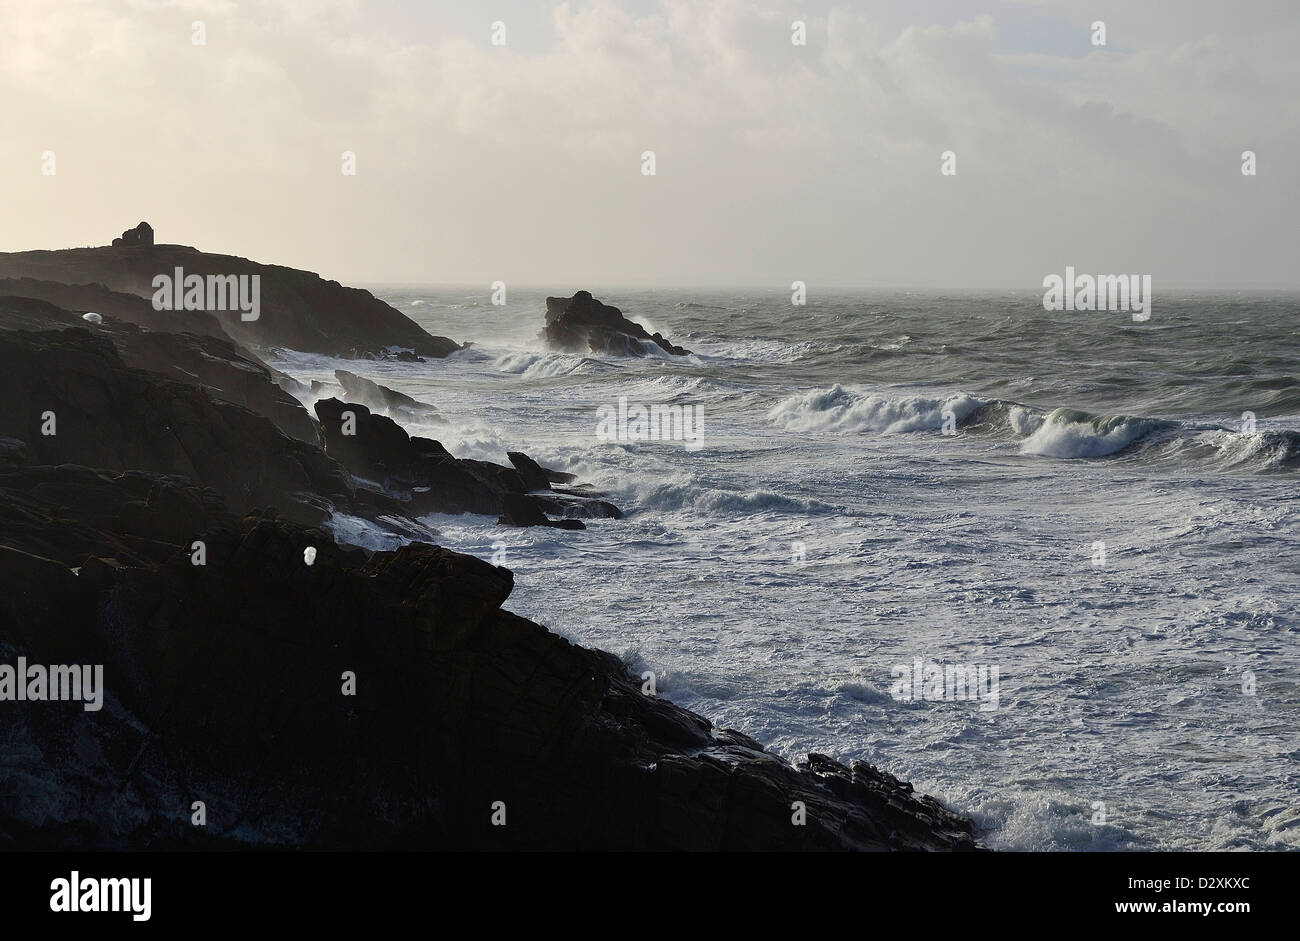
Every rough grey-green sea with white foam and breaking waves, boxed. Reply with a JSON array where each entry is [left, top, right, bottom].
[[269, 285, 1300, 850]]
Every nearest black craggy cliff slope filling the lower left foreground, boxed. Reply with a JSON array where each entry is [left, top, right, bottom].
[[0, 467, 975, 850]]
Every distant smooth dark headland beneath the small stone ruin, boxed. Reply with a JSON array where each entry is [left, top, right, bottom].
[[0, 244, 460, 357]]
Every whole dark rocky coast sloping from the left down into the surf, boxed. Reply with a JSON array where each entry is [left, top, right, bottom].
[[0, 244, 975, 850]]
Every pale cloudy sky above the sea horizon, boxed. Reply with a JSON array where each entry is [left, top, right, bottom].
[[0, 0, 1300, 287]]
